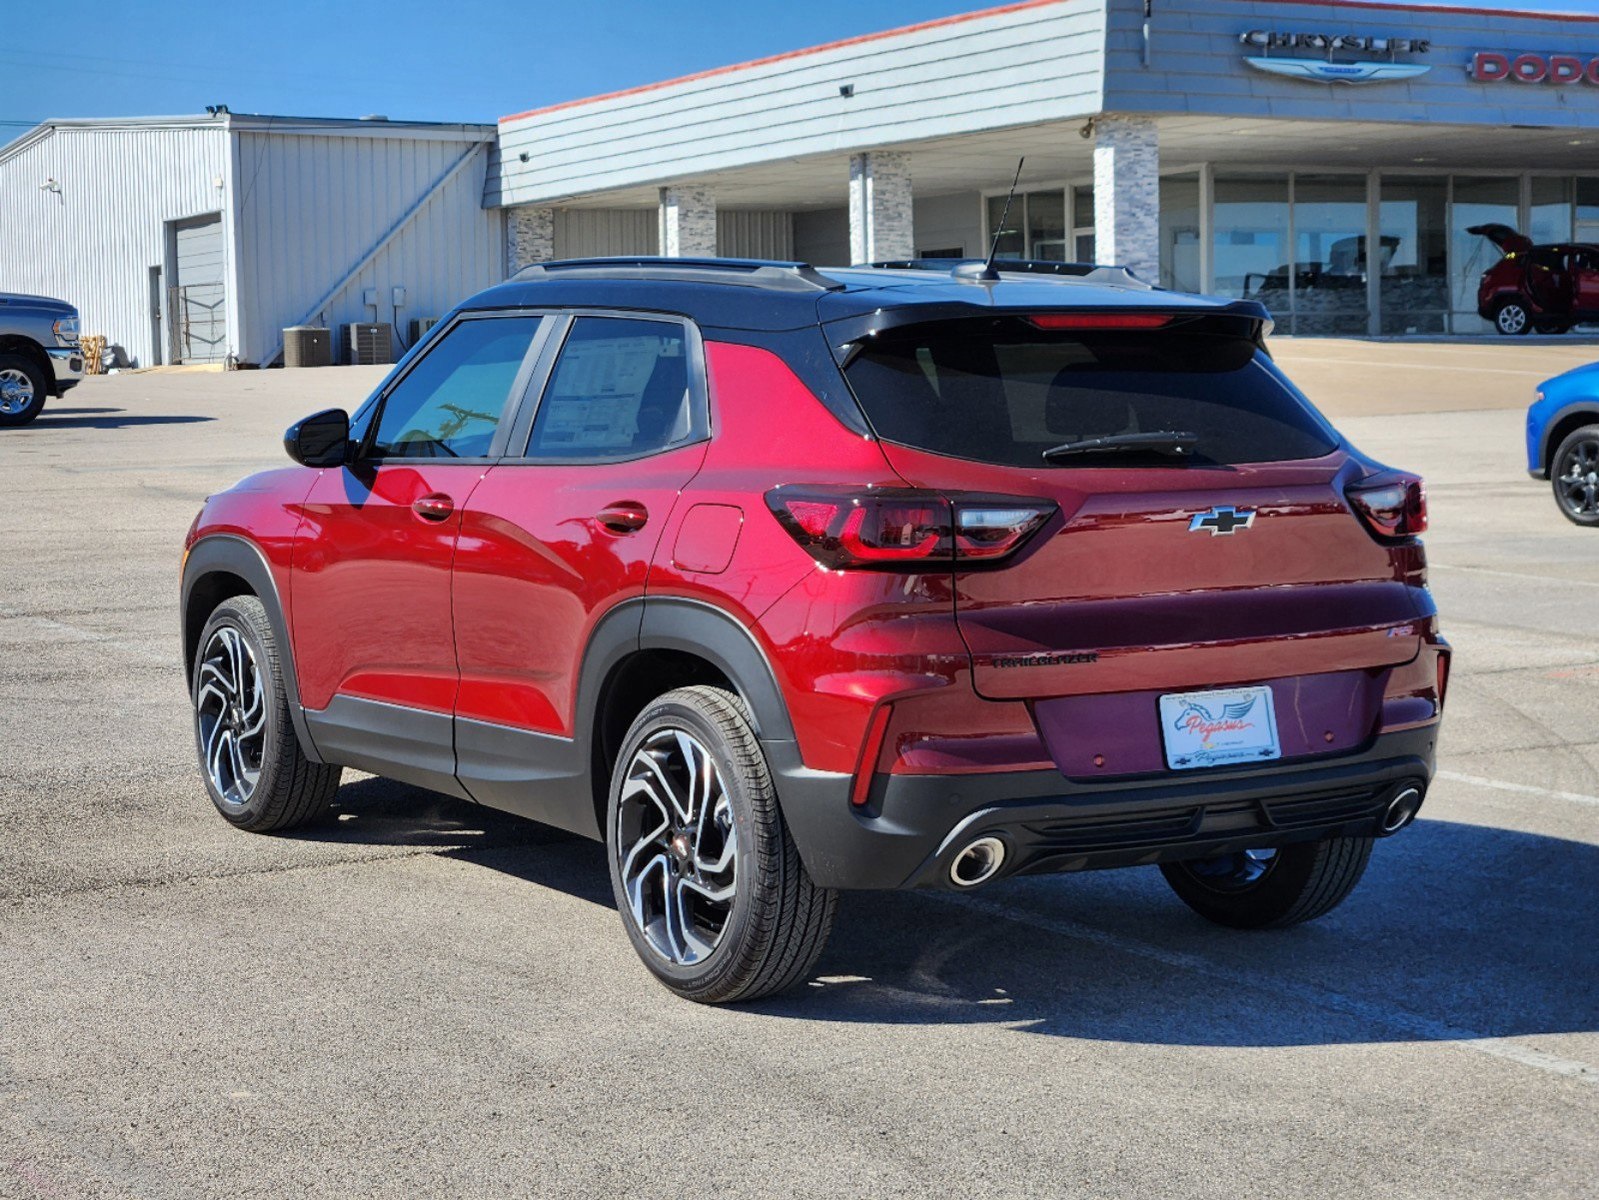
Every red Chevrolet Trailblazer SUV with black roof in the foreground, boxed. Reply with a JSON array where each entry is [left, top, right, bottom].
[[182, 259, 1449, 1002]]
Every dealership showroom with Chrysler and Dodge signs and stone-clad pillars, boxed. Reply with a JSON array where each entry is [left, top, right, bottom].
[[484, 0, 1599, 336]]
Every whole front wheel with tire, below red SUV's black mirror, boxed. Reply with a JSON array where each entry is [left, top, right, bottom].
[[189, 595, 341, 834]]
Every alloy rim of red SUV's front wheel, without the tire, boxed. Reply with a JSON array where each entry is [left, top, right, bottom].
[[195, 626, 267, 808]]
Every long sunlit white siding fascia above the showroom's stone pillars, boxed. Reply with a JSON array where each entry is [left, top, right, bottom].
[[488, 0, 1107, 205]]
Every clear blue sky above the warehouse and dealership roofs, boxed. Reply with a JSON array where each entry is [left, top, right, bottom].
[[9, 0, 1599, 133]]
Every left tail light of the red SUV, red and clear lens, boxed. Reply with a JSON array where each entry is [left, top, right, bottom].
[[766, 485, 1055, 571]]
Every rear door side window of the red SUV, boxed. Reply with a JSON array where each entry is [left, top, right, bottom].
[[528, 317, 700, 459]]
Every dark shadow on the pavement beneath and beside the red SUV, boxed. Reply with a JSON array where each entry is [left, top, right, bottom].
[[296, 793, 1599, 1046]]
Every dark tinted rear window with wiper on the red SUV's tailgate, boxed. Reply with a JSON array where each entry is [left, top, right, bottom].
[[844, 317, 1337, 467]]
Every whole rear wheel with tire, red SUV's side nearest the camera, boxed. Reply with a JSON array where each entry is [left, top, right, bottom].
[[606, 686, 838, 1005]]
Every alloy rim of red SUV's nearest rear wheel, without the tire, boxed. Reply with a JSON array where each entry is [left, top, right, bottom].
[[616, 728, 739, 966]]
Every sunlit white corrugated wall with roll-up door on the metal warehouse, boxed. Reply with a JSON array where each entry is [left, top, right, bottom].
[[0, 126, 227, 365]]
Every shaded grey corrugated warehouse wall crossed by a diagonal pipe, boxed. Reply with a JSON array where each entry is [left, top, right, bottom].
[[235, 133, 504, 362]]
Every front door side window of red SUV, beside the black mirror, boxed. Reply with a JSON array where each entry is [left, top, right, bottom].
[[368, 317, 540, 458]]
